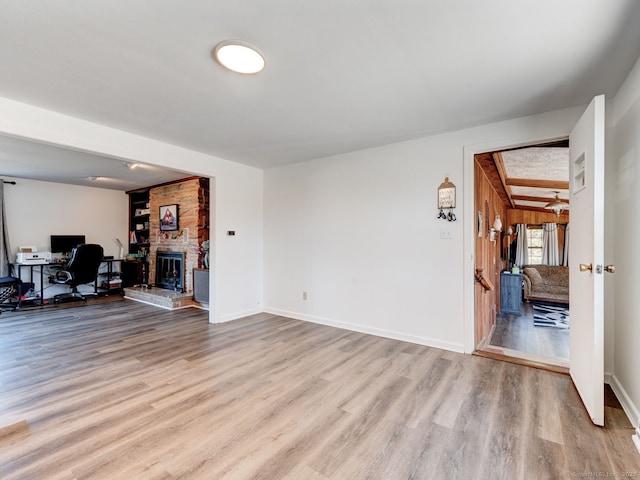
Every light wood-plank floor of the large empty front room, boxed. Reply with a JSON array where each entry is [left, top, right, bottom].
[[0, 298, 640, 480]]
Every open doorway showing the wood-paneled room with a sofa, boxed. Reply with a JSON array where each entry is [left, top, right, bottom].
[[474, 139, 570, 371]]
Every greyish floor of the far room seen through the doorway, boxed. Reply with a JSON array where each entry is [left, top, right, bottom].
[[489, 303, 569, 362]]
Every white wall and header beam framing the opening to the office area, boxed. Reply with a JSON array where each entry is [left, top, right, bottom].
[[0, 98, 263, 321]]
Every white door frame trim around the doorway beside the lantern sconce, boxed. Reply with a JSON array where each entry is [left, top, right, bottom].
[[463, 131, 577, 353]]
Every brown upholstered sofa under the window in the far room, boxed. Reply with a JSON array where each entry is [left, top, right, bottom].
[[522, 265, 569, 304]]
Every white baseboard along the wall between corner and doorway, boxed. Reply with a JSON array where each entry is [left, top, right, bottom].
[[264, 308, 464, 353]]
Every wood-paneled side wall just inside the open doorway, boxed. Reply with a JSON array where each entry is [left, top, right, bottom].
[[475, 161, 507, 345]]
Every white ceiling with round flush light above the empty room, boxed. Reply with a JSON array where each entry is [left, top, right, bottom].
[[0, 0, 640, 189]]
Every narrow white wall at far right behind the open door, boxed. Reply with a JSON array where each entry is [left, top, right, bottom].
[[612, 56, 640, 436]]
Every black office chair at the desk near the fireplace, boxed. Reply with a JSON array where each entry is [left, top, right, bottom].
[[53, 243, 104, 303]]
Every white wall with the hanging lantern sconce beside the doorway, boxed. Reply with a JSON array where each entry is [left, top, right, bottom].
[[264, 107, 584, 351]]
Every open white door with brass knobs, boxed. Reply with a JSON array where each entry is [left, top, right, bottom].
[[569, 95, 605, 426]]
